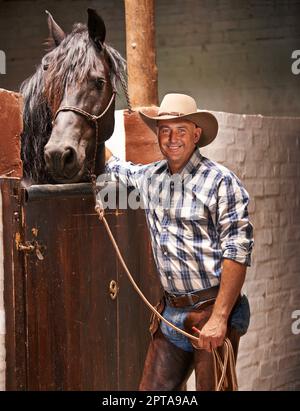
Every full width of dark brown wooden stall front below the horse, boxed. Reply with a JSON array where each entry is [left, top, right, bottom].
[[1, 179, 160, 390]]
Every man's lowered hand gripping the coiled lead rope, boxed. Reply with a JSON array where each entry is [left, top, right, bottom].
[[193, 314, 227, 352]]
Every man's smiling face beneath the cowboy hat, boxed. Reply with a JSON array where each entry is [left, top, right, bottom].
[[157, 119, 201, 173]]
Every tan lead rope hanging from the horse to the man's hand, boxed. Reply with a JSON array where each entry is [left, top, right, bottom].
[[91, 181, 238, 391]]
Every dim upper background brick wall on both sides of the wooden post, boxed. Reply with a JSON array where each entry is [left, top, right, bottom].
[[0, 0, 300, 116]]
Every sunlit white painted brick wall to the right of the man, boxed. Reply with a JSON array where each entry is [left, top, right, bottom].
[[197, 113, 300, 390]]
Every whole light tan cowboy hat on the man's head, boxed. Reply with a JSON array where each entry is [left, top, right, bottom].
[[139, 93, 218, 147]]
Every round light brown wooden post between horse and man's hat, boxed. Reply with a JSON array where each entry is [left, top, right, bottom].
[[125, 0, 158, 107]]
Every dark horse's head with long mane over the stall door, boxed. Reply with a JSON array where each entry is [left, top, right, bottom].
[[20, 9, 128, 184]]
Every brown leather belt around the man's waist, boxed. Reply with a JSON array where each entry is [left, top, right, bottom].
[[164, 285, 220, 308]]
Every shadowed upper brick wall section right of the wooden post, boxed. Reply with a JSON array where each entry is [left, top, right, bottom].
[[156, 0, 300, 116]]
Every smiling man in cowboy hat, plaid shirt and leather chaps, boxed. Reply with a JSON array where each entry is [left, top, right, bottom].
[[106, 94, 253, 391]]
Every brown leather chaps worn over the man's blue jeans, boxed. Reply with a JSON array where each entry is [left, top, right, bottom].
[[139, 305, 240, 391]]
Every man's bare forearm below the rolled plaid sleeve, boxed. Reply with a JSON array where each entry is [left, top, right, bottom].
[[212, 258, 247, 321]]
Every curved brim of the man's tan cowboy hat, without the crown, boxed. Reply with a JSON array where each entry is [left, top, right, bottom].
[[139, 110, 218, 147]]
